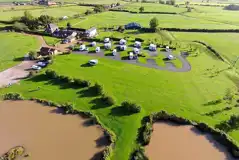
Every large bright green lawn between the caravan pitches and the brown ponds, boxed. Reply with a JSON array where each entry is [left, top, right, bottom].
[[0, 49, 239, 160]]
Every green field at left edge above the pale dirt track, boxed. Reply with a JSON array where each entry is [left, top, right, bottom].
[[0, 33, 39, 71]]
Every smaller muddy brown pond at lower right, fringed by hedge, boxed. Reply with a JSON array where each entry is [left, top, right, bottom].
[[146, 122, 234, 160]]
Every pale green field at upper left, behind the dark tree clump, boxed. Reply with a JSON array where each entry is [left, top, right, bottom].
[[0, 6, 91, 20]]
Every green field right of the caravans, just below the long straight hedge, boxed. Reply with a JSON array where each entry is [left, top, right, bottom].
[[173, 32, 239, 66]]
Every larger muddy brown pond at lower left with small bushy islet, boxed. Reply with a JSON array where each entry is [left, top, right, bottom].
[[0, 101, 107, 160]]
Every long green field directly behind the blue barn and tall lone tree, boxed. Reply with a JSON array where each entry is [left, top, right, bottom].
[[59, 12, 239, 29]]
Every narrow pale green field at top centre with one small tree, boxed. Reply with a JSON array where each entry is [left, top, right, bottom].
[[124, 3, 186, 13]]
